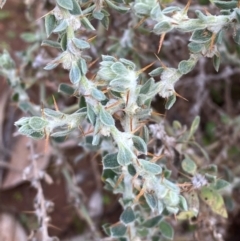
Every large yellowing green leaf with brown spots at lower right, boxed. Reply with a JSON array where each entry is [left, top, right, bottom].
[[200, 187, 228, 218]]
